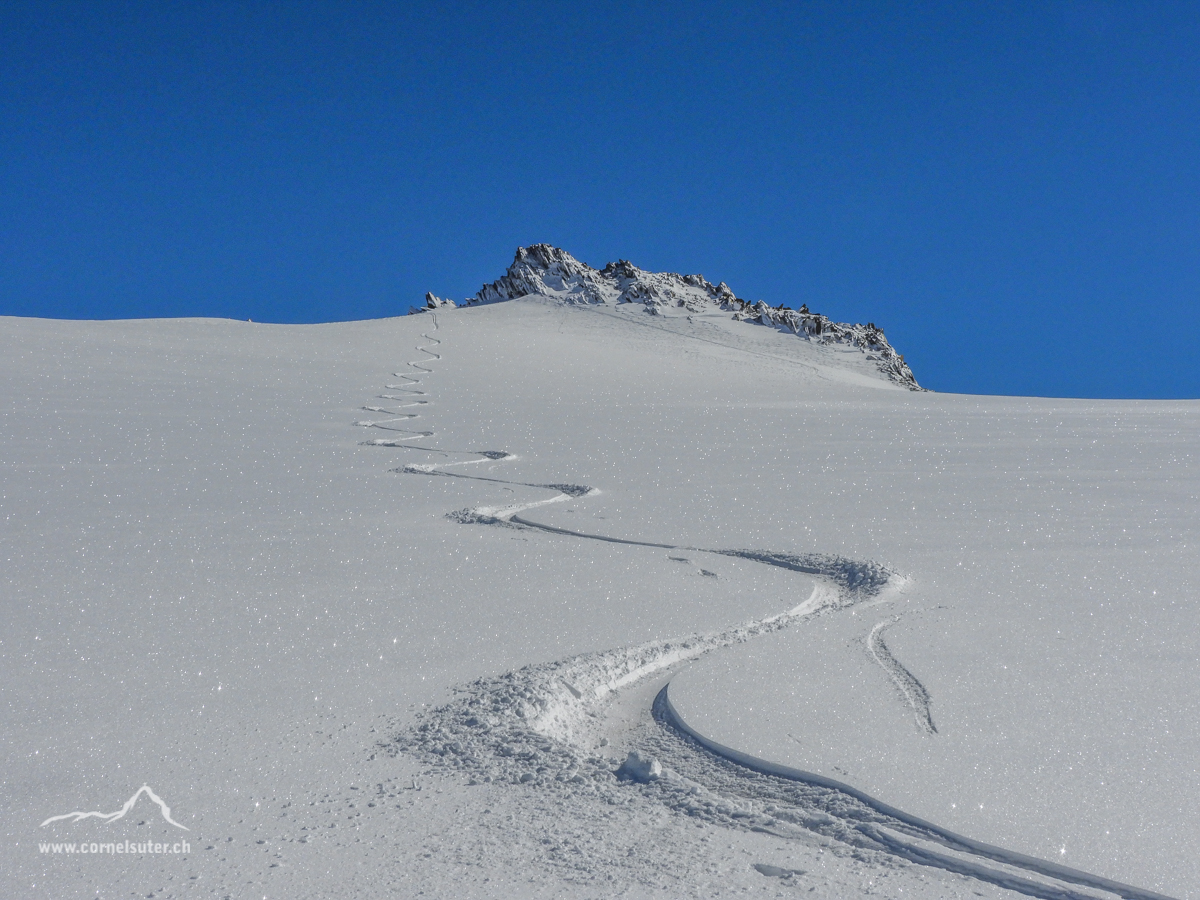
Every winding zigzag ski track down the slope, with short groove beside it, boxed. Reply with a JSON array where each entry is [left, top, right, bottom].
[[355, 312, 1172, 900]]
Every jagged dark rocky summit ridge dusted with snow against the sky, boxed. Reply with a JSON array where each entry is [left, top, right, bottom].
[[413, 244, 922, 390]]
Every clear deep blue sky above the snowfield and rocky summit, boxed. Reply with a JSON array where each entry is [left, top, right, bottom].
[[0, 0, 1200, 397]]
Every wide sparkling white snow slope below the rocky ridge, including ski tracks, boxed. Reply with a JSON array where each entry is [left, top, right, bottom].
[[0, 283, 1200, 898]]
